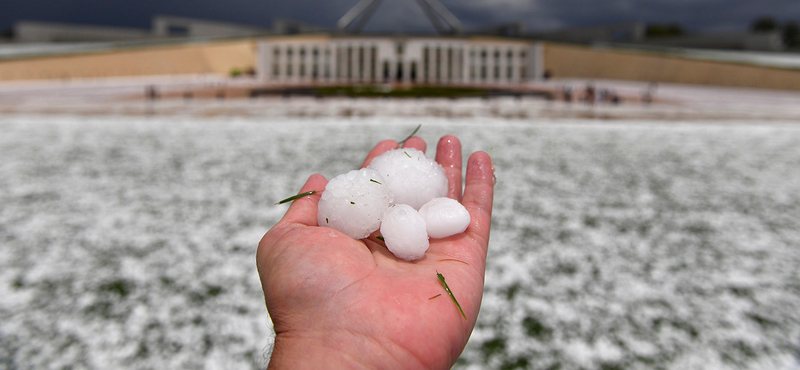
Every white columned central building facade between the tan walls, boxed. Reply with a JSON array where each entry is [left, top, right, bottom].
[[256, 35, 543, 85]]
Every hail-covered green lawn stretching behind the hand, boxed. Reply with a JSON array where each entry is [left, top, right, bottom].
[[0, 102, 800, 369]]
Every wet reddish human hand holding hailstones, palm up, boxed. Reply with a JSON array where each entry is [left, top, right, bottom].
[[257, 136, 494, 369]]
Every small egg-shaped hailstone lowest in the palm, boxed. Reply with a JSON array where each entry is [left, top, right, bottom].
[[381, 204, 430, 261]]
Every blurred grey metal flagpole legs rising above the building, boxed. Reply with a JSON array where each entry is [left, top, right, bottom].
[[336, 0, 462, 34]]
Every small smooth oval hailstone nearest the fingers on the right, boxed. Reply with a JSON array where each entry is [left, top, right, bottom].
[[419, 198, 470, 239]]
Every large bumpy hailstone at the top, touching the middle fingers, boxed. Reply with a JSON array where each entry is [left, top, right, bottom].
[[367, 148, 447, 209]]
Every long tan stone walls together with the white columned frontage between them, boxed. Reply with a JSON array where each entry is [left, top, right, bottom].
[[0, 34, 800, 90]]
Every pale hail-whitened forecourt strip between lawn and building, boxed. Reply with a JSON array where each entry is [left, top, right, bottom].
[[0, 75, 800, 122]]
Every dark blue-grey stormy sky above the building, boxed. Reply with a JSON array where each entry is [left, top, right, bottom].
[[0, 0, 800, 31]]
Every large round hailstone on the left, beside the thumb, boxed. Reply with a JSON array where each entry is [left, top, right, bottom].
[[317, 168, 392, 239]]
